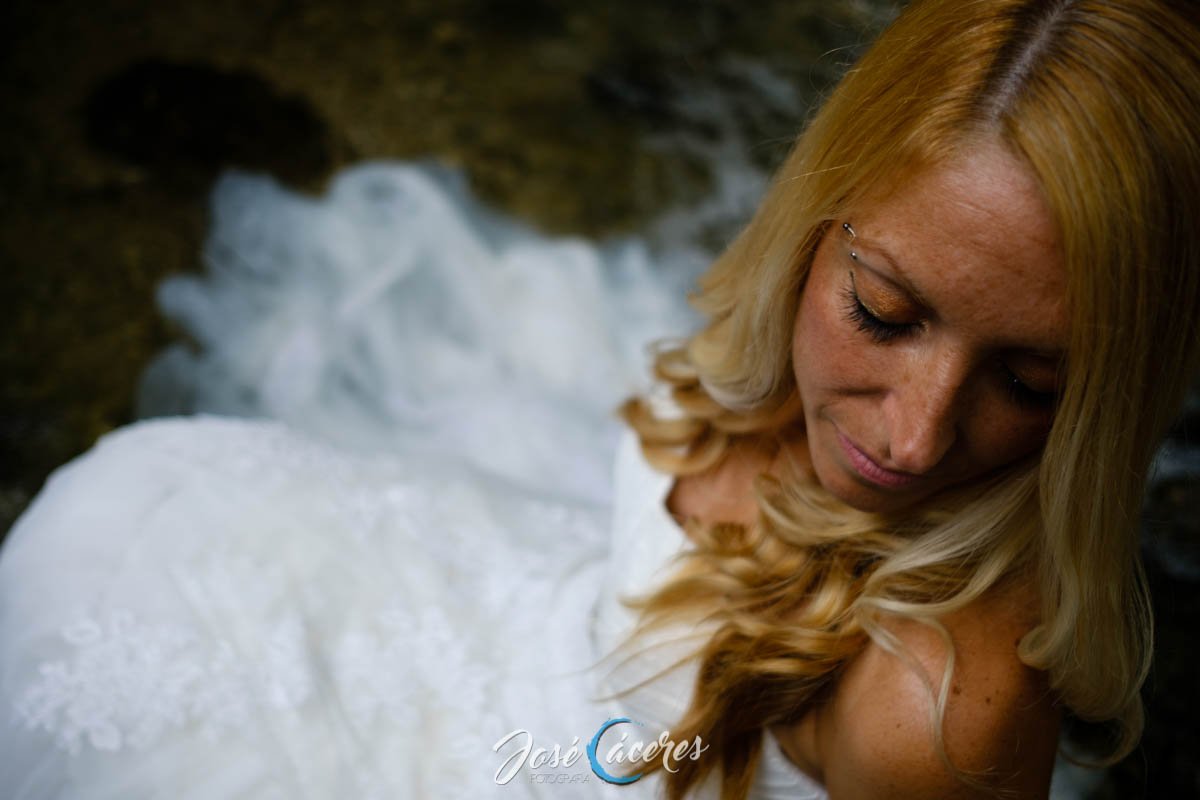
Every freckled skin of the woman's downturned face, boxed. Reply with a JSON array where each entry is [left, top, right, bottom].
[[792, 145, 1067, 511]]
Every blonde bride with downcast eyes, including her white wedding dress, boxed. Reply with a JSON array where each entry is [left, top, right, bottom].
[[0, 0, 1200, 799]]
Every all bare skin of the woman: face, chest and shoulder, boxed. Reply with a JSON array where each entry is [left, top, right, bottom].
[[668, 146, 1067, 800]]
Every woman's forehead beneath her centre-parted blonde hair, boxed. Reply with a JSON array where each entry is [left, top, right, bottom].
[[852, 145, 1068, 353]]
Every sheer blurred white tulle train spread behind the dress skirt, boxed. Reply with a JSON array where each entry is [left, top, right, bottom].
[[139, 163, 702, 504]]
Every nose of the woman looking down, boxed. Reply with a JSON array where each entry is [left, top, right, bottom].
[[883, 359, 965, 475]]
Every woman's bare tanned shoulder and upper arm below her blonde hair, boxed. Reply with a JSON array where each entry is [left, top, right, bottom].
[[815, 584, 1060, 800]]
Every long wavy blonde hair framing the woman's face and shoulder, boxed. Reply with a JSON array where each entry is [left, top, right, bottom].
[[623, 0, 1200, 798]]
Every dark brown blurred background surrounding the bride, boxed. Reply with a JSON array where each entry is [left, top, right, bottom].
[[0, 0, 1200, 799]]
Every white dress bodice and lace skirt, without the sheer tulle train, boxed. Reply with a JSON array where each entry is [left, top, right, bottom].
[[0, 416, 823, 799]]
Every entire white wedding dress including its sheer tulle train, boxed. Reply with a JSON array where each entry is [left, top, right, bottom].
[[0, 166, 826, 800]]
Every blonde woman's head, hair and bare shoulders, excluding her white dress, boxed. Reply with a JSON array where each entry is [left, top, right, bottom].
[[626, 1, 1200, 798]]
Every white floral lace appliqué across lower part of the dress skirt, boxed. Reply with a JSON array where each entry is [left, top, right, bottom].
[[16, 597, 499, 765]]
